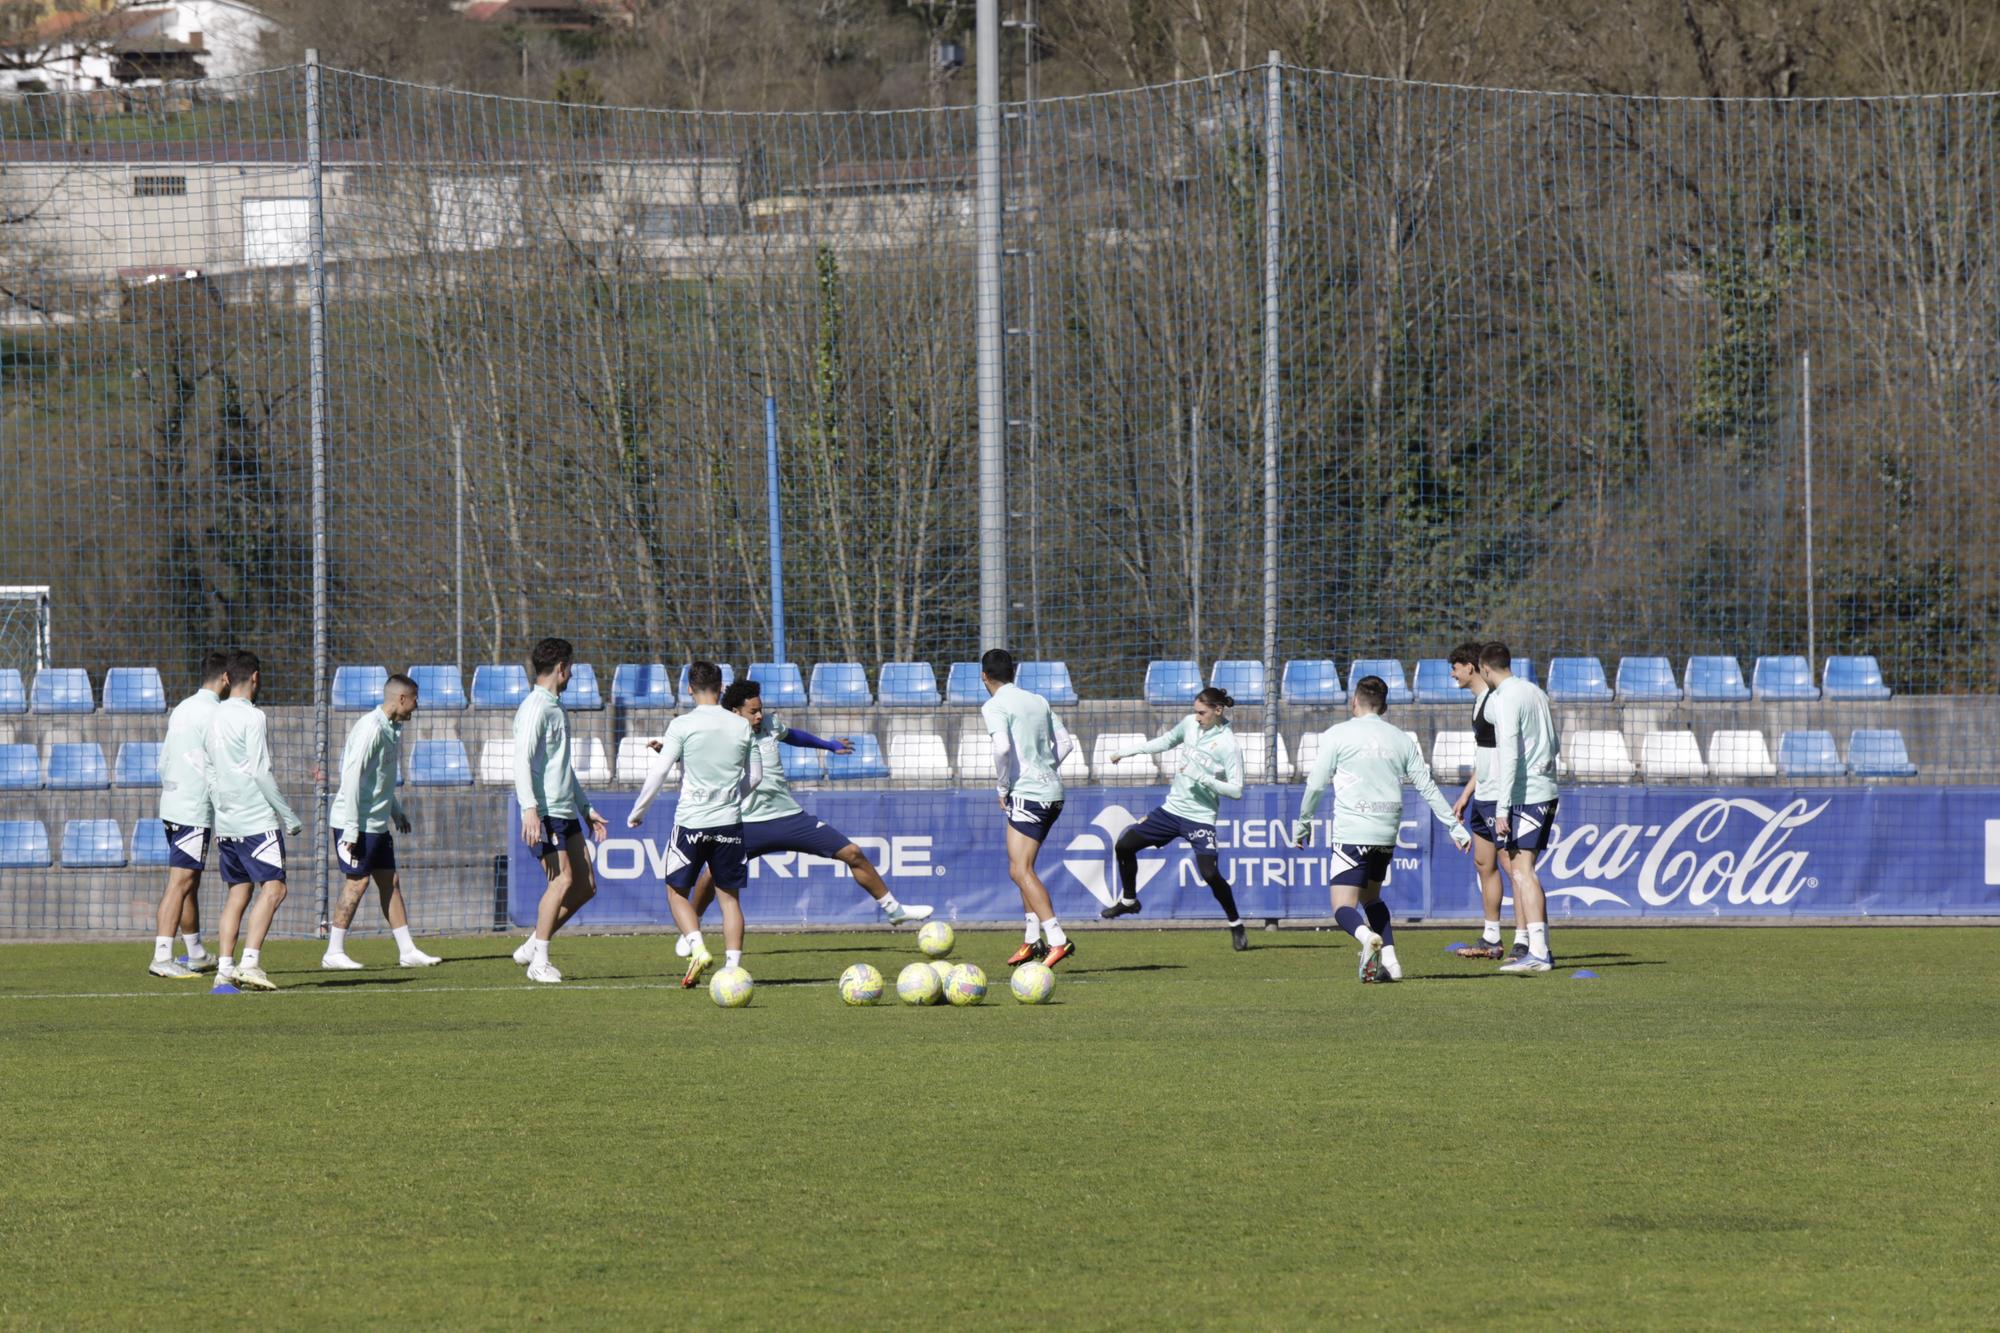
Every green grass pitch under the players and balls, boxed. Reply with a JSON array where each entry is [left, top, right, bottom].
[[0, 929, 2000, 1329]]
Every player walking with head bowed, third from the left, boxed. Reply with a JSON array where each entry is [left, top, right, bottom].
[[320, 675, 442, 971]]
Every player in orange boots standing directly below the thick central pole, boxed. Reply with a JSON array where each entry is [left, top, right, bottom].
[[980, 648, 1076, 967]]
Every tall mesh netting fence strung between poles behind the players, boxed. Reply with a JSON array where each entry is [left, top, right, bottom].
[[0, 66, 2000, 933]]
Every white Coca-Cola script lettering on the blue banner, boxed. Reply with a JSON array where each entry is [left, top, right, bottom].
[[1542, 797, 1832, 907]]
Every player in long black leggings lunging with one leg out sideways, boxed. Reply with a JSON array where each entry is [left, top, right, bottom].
[[1098, 685, 1250, 953]]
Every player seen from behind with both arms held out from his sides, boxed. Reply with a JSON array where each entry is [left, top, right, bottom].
[[1292, 677, 1472, 983]]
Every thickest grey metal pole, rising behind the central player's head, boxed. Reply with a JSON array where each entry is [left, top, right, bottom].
[[972, 0, 1008, 648]]
